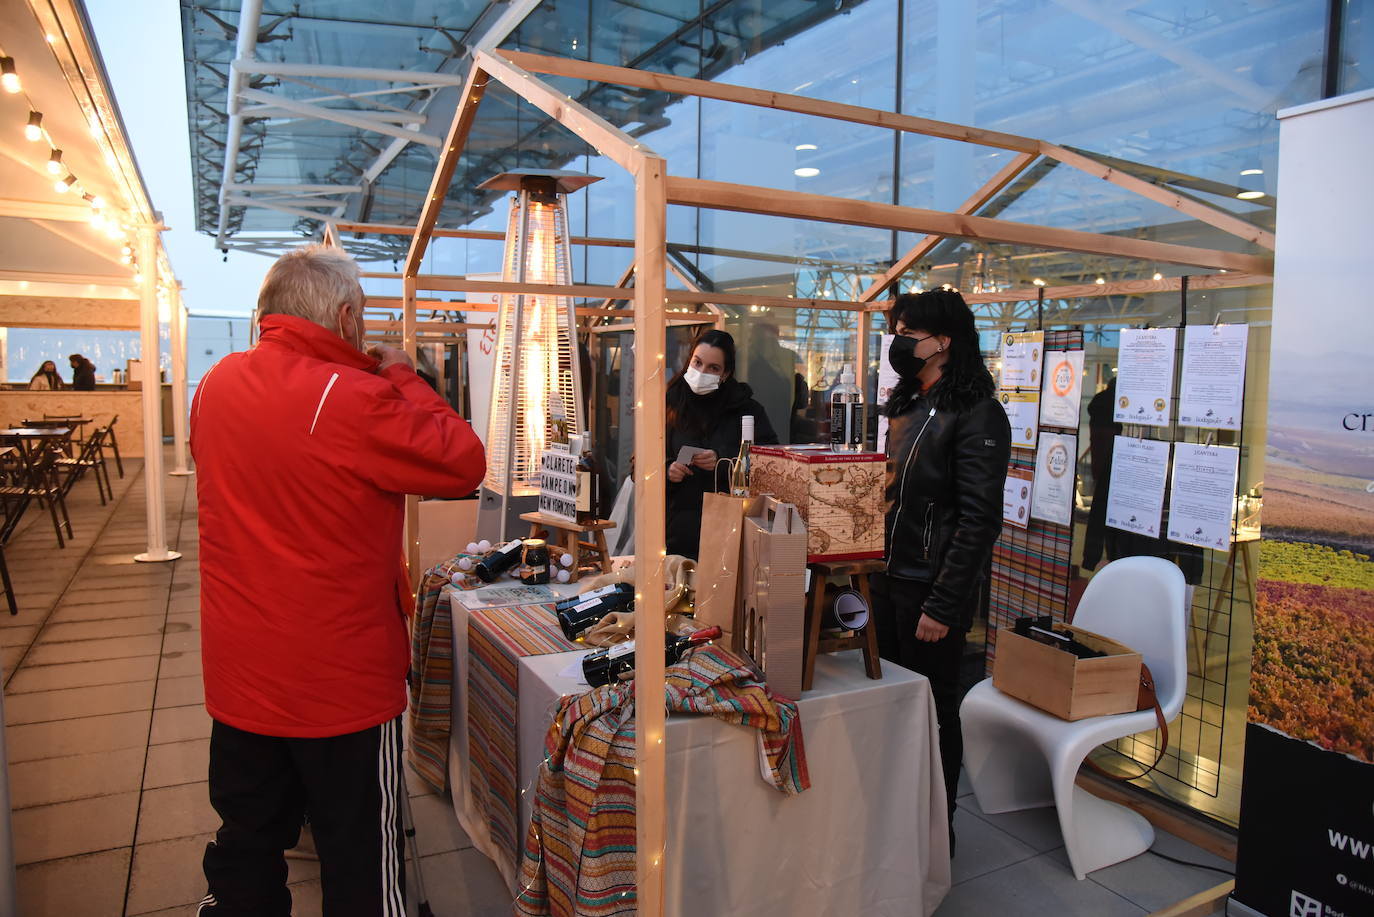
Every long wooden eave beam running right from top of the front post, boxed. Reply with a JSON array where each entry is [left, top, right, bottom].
[[668, 176, 1274, 274]]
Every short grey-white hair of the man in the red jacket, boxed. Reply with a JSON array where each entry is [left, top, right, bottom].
[[258, 243, 363, 333]]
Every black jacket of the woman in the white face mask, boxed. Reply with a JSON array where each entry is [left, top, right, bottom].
[[664, 379, 778, 560]]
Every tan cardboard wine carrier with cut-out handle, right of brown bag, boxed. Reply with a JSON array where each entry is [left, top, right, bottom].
[[735, 496, 807, 700]]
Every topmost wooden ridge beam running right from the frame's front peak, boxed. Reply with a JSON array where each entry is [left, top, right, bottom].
[[497, 51, 1040, 153]]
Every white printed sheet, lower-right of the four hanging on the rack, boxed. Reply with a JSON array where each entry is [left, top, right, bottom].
[[1169, 443, 1241, 551]]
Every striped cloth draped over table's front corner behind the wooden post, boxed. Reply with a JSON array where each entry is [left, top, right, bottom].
[[514, 646, 811, 917]]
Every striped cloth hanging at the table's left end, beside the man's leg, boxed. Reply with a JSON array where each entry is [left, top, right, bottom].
[[405, 555, 469, 793]]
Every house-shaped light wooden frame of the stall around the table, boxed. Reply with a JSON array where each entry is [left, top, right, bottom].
[[326, 51, 1274, 917]]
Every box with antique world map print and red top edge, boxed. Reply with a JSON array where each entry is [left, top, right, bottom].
[[749, 445, 888, 562]]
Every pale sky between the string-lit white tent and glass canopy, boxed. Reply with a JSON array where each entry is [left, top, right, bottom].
[[85, 0, 271, 315]]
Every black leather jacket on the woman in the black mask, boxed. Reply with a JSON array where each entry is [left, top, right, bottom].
[[885, 381, 1011, 630]]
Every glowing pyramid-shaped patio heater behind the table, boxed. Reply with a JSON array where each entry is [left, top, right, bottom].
[[477, 169, 600, 542]]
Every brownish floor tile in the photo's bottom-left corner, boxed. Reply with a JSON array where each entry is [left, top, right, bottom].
[[15, 847, 132, 917]]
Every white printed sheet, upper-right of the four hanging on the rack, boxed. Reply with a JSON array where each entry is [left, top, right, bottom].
[[1179, 324, 1250, 430]]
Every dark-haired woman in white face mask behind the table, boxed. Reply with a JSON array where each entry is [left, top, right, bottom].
[[666, 330, 778, 560]]
